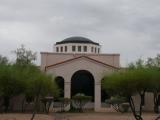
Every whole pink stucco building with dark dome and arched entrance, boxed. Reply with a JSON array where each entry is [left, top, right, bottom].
[[41, 37, 120, 111]]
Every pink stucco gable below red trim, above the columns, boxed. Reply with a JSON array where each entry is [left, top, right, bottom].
[[47, 58, 114, 82]]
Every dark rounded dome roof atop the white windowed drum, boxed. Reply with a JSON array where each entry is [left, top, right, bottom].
[[56, 36, 99, 45]]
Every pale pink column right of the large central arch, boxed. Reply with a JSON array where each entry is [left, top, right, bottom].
[[94, 82, 101, 111]]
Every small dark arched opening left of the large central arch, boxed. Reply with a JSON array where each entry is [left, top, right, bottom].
[[55, 76, 64, 97]]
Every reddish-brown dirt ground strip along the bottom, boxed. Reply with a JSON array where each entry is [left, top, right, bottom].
[[0, 112, 157, 120]]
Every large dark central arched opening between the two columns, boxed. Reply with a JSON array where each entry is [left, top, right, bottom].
[[71, 70, 94, 101]]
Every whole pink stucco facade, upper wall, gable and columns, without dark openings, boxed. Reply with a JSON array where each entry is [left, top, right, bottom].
[[41, 52, 120, 111]]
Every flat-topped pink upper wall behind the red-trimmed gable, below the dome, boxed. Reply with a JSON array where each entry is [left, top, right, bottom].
[[41, 52, 120, 70]]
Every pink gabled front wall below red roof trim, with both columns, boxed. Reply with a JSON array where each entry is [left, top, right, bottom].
[[46, 57, 115, 111]]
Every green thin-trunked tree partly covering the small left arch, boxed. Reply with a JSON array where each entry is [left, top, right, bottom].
[[26, 66, 59, 120]]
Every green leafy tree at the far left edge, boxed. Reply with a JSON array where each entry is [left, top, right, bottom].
[[0, 64, 24, 112]]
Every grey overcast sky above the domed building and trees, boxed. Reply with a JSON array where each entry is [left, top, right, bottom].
[[0, 0, 160, 66]]
